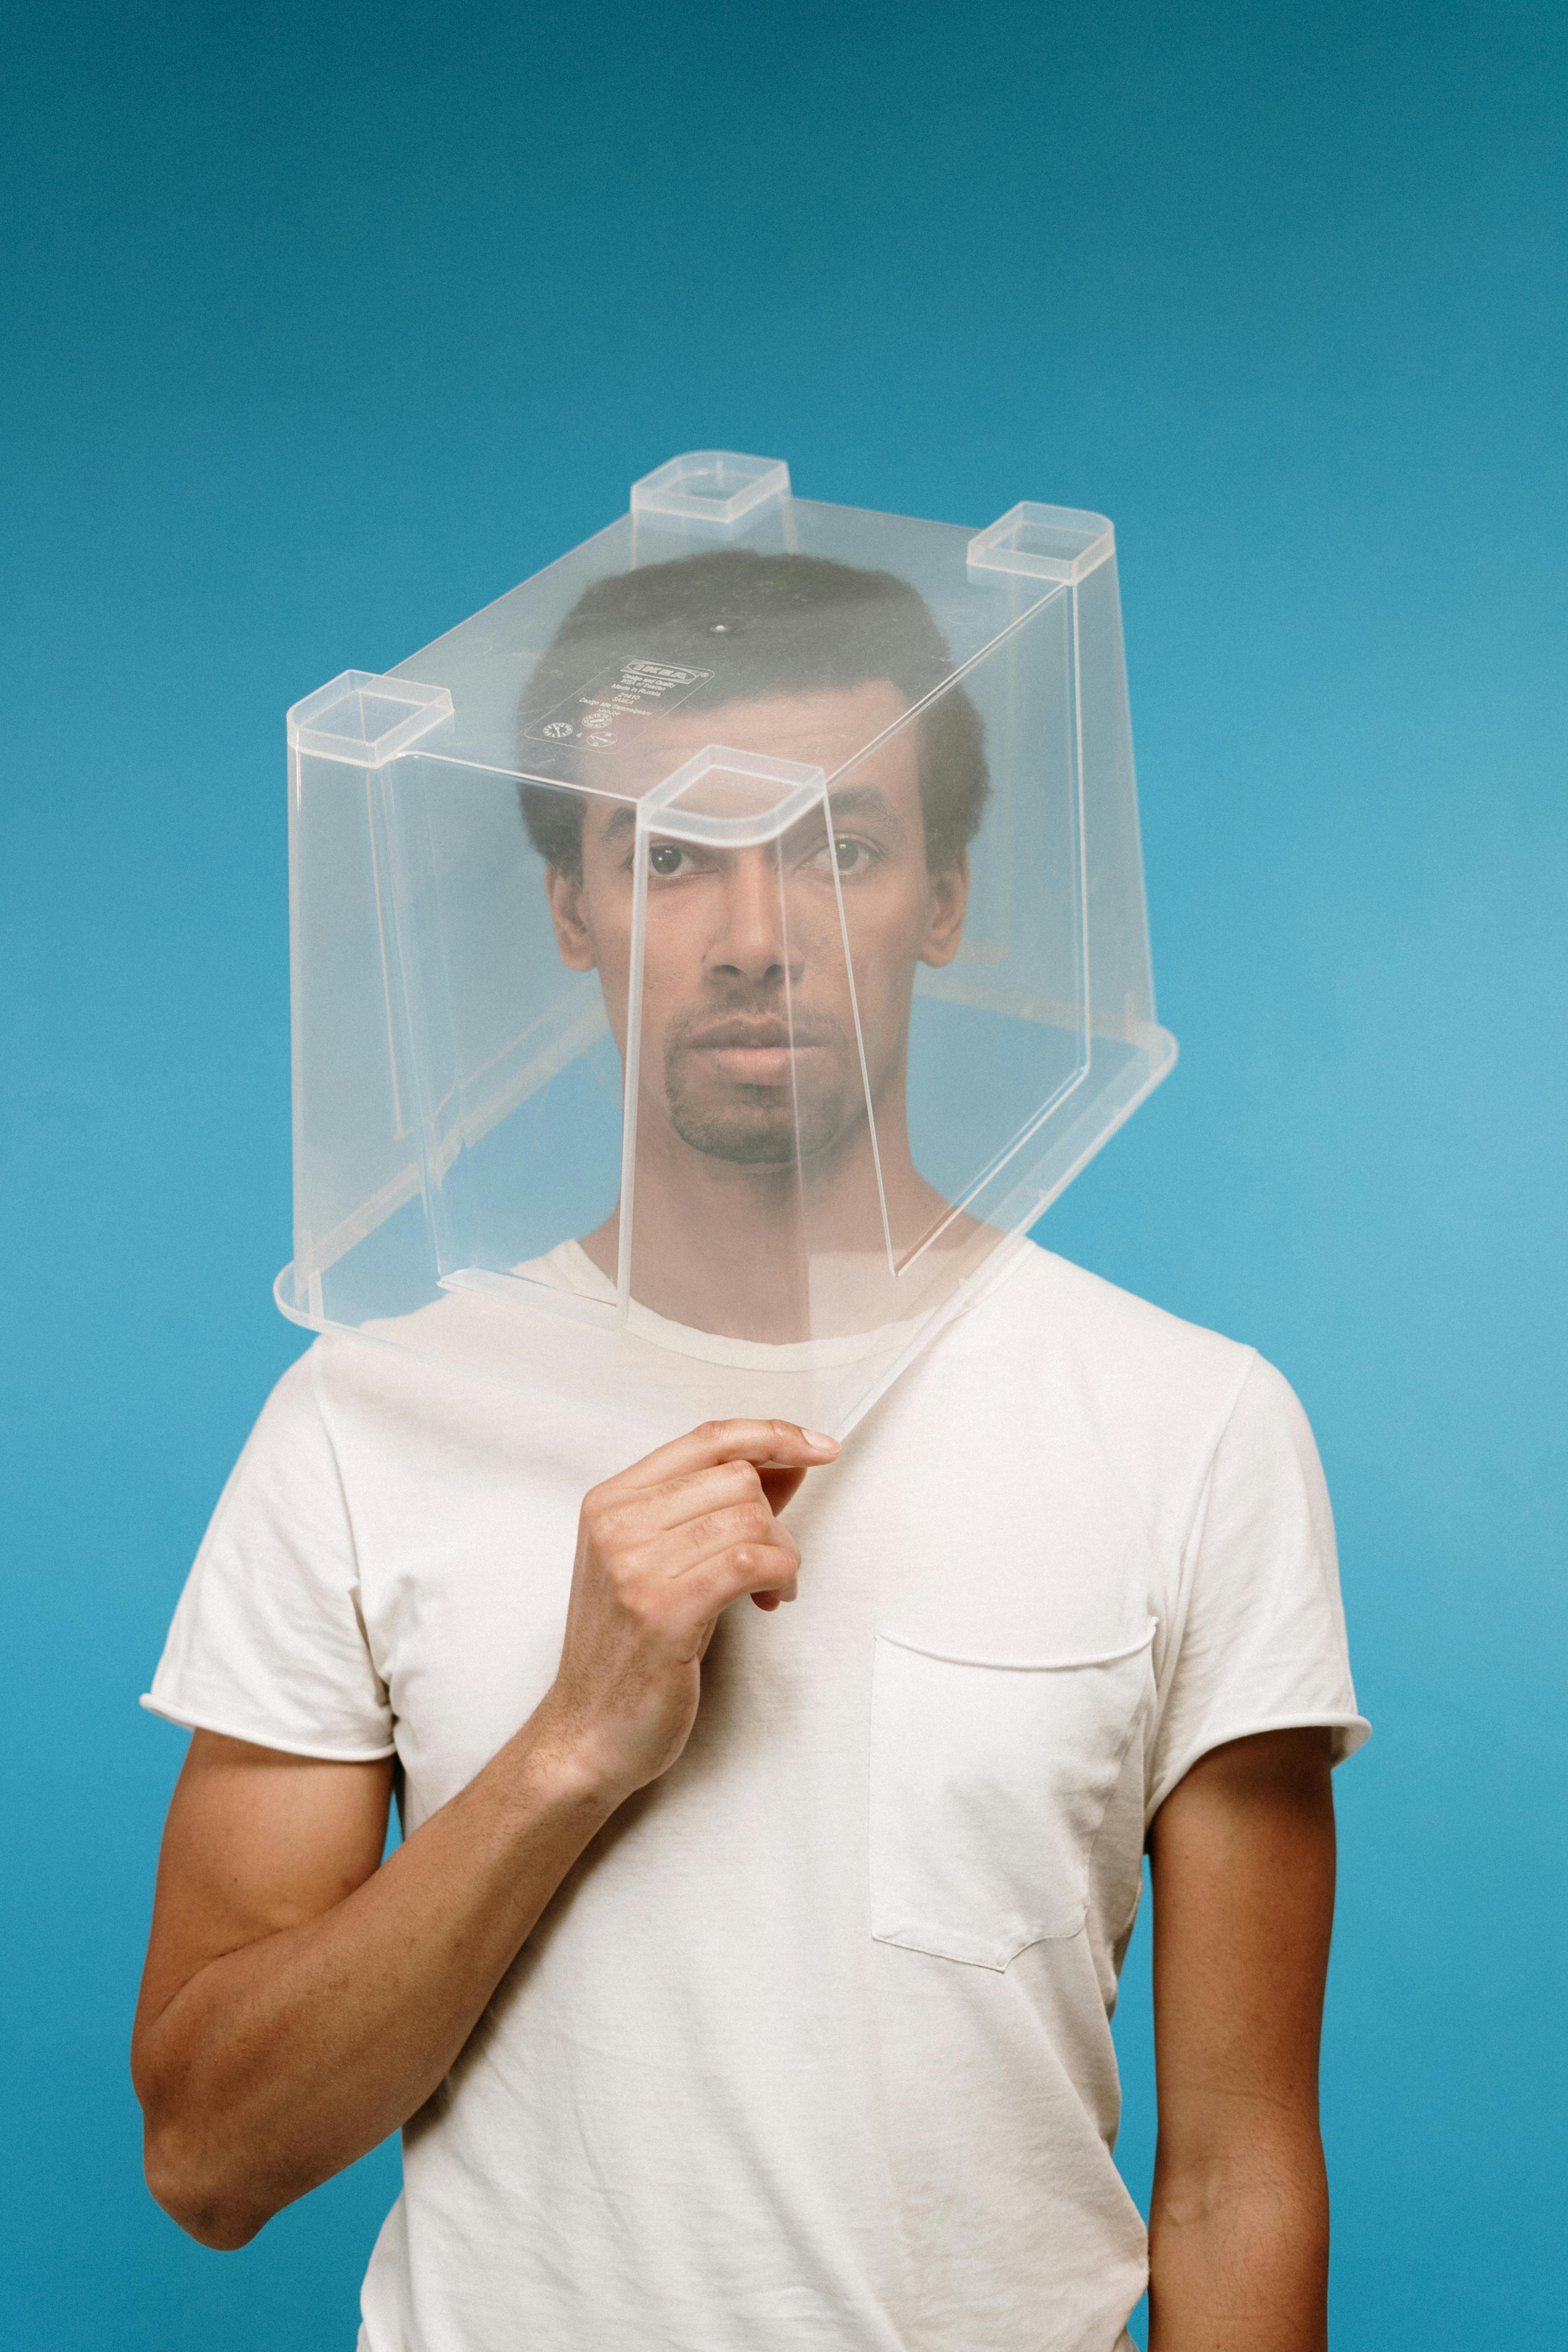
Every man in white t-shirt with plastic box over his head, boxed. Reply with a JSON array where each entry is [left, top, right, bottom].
[[134, 553, 1363, 2352]]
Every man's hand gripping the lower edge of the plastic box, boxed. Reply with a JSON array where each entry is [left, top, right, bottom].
[[536, 1421, 839, 1804]]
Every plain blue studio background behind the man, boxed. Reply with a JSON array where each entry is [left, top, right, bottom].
[[0, 0, 1568, 2352]]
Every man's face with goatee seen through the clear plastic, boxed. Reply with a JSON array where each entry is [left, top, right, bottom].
[[550, 682, 969, 1167]]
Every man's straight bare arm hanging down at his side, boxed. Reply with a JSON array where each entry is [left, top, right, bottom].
[[1150, 1729, 1335, 2352]]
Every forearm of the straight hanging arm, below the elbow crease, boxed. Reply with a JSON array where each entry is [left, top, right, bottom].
[[1150, 2136, 1328, 2352]]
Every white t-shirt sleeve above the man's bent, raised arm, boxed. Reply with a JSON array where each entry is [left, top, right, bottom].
[[141, 1350, 392, 1764]]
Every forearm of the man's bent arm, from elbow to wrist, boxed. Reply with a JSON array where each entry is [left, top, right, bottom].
[[136, 1719, 613, 2246]]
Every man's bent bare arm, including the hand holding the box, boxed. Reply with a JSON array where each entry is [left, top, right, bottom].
[[132, 1421, 837, 2246]]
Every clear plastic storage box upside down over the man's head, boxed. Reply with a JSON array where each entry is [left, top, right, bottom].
[[278, 452, 1176, 1435]]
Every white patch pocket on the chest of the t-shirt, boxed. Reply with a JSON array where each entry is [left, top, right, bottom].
[[870, 1625, 1154, 1969]]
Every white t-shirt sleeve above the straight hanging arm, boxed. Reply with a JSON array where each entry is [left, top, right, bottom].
[[1147, 1357, 1370, 1818]]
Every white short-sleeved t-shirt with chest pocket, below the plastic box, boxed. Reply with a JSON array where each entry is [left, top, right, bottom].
[[146, 1249, 1366, 2352]]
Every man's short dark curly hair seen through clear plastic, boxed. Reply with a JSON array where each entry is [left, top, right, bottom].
[[517, 548, 990, 875]]
